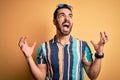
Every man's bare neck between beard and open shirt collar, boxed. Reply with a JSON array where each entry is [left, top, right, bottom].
[[56, 34, 70, 45]]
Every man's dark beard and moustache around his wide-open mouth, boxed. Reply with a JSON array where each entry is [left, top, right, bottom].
[[56, 21, 73, 36]]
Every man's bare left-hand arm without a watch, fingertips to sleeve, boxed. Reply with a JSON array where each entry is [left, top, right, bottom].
[[19, 37, 47, 80]]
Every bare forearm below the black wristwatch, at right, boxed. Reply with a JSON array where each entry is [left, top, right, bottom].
[[88, 58, 101, 80]]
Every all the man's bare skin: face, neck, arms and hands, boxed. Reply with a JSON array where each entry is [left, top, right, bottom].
[[19, 8, 108, 80]]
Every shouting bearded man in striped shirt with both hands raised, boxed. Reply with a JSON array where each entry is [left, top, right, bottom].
[[19, 4, 108, 80]]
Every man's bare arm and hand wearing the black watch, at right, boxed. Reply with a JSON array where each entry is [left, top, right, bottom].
[[83, 32, 108, 80]]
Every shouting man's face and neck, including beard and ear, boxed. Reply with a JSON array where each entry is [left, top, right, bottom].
[[53, 8, 73, 45]]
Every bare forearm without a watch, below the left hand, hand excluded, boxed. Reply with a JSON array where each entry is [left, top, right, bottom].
[[26, 57, 44, 80]]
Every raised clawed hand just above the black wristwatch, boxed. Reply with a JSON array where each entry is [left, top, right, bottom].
[[91, 32, 108, 54]]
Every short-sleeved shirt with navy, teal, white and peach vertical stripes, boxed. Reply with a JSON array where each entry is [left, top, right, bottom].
[[36, 36, 93, 80]]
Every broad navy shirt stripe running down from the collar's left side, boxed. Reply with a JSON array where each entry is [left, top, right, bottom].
[[50, 41, 60, 80]]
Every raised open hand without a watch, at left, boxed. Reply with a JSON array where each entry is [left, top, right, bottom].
[[18, 37, 36, 58]]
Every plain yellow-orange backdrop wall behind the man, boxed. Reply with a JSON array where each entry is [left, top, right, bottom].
[[0, 0, 120, 80]]
